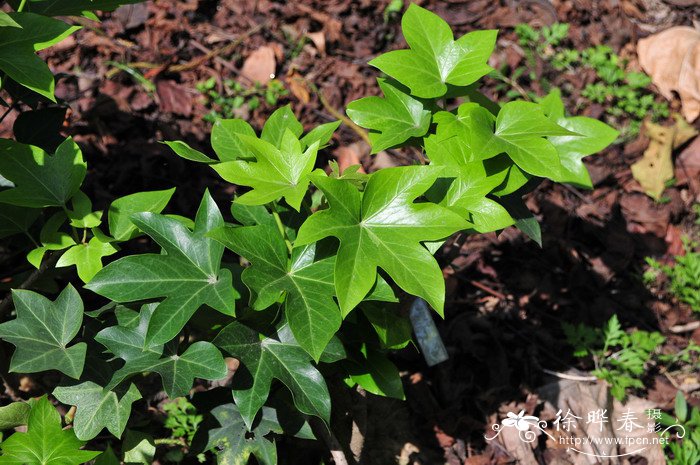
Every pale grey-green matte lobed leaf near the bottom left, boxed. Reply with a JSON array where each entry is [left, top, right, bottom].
[[53, 381, 141, 441]]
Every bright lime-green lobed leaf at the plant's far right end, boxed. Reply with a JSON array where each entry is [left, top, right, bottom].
[[541, 89, 619, 189]]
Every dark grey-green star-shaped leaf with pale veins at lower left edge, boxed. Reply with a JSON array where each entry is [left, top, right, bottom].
[[0, 284, 87, 379]]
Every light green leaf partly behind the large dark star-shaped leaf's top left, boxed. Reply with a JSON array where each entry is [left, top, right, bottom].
[[109, 187, 175, 241]]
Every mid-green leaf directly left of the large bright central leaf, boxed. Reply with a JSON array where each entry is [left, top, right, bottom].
[[210, 215, 342, 361]]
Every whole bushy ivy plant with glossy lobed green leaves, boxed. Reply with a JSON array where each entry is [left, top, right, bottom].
[[0, 0, 617, 464]]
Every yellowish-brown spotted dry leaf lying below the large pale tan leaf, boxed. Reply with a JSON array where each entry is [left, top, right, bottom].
[[631, 115, 698, 200]]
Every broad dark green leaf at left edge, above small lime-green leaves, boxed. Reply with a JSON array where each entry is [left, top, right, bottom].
[[0, 138, 87, 208]]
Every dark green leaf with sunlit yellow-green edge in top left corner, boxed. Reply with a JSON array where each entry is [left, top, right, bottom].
[[0, 12, 80, 102]]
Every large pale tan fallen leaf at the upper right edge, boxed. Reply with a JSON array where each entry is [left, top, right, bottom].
[[637, 26, 700, 123]]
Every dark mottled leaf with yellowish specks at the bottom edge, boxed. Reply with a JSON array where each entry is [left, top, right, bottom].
[[206, 404, 283, 465]]
